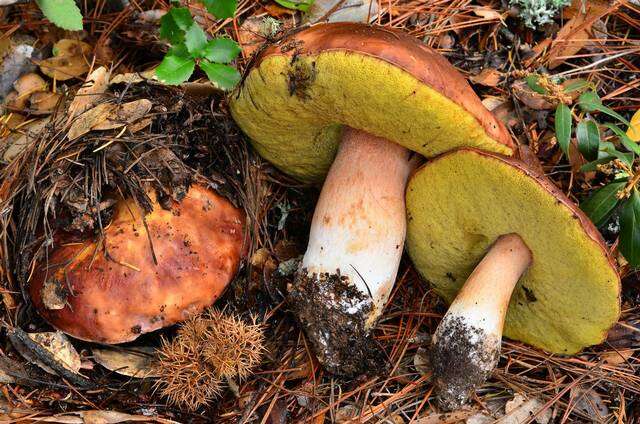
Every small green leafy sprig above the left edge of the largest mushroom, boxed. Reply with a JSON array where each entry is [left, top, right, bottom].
[[156, 0, 240, 90]]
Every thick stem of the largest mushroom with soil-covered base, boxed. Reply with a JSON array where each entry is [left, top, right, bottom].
[[290, 128, 416, 375]]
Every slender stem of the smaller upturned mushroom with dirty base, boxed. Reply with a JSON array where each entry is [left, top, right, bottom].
[[431, 234, 532, 409]]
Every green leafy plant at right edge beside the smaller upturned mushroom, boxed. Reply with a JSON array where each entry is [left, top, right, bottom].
[[526, 74, 640, 266]]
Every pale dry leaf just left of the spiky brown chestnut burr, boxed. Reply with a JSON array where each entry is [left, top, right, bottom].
[[91, 346, 158, 378]]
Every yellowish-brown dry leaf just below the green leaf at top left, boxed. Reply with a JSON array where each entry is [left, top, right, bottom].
[[38, 39, 91, 81]]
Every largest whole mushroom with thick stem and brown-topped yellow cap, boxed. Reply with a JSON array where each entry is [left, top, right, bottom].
[[230, 23, 513, 375]]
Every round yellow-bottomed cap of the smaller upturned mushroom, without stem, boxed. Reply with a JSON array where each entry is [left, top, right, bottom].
[[407, 149, 620, 354]]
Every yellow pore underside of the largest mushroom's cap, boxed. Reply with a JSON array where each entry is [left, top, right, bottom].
[[231, 50, 511, 182]]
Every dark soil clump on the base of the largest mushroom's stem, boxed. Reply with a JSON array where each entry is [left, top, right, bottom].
[[288, 268, 386, 376]]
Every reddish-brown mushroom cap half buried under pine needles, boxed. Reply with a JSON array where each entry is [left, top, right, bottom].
[[29, 185, 245, 343]]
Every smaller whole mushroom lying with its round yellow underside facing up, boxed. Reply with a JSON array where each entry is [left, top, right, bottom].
[[406, 149, 620, 409]]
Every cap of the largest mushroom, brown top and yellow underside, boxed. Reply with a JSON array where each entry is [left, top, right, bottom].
[[230, 23, 513, 182]]
